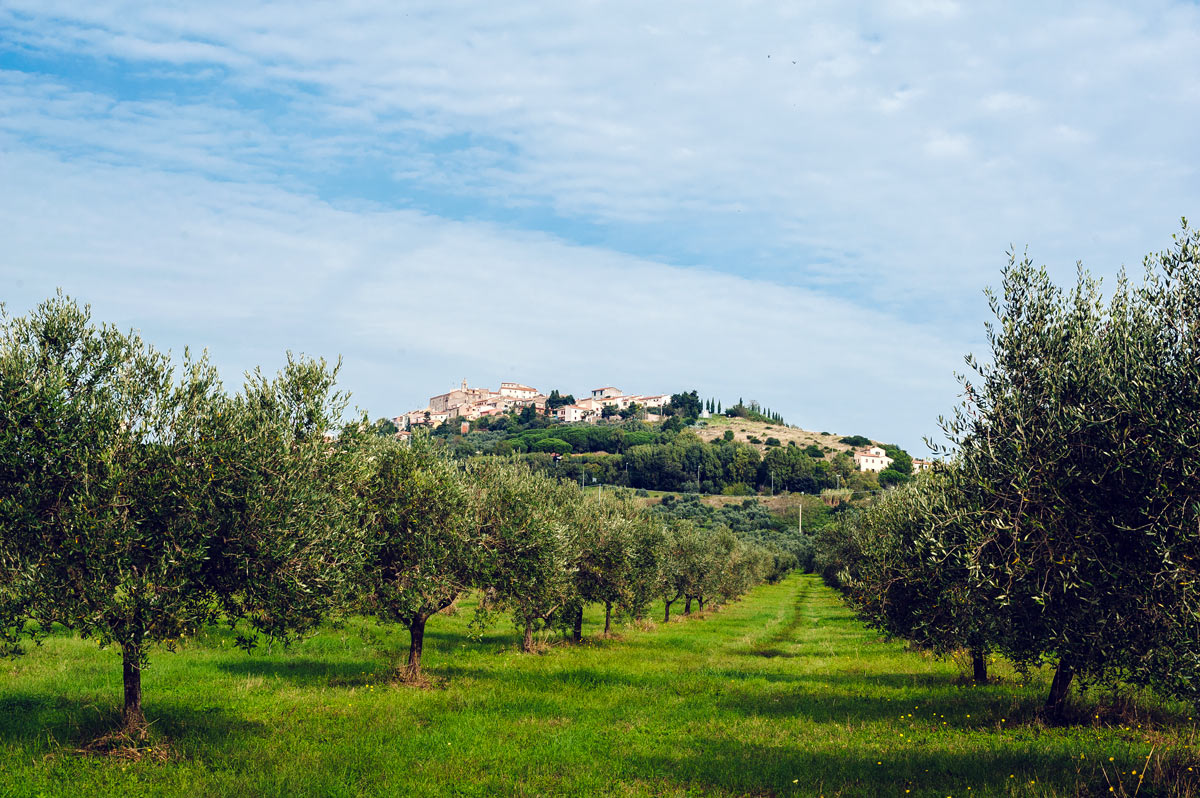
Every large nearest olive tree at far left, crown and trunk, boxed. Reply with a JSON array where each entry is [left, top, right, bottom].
[[0, 296, 360, 731]]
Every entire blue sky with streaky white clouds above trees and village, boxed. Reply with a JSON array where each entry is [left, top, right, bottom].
[[0, 0, 1200, 456]]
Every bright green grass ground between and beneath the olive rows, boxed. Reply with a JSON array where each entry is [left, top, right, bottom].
[[0, 575, 1200, 798]]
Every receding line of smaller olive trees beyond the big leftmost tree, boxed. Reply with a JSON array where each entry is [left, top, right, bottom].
[[355, 433, 776, 677]]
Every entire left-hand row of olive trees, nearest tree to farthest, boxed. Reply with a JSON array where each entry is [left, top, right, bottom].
[[0, 295, 777, 728]]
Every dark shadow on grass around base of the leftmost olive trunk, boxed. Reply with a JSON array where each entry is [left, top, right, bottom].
[[0, 692, 266, 755]]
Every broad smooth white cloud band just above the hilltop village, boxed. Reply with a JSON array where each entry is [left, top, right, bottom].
[[0, 147, 959, 448]]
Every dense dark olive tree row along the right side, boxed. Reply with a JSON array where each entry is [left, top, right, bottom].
[[821, 222, 1200, 719]]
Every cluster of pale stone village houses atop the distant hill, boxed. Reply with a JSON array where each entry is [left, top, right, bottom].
[[392, 379, 671, 430]]
